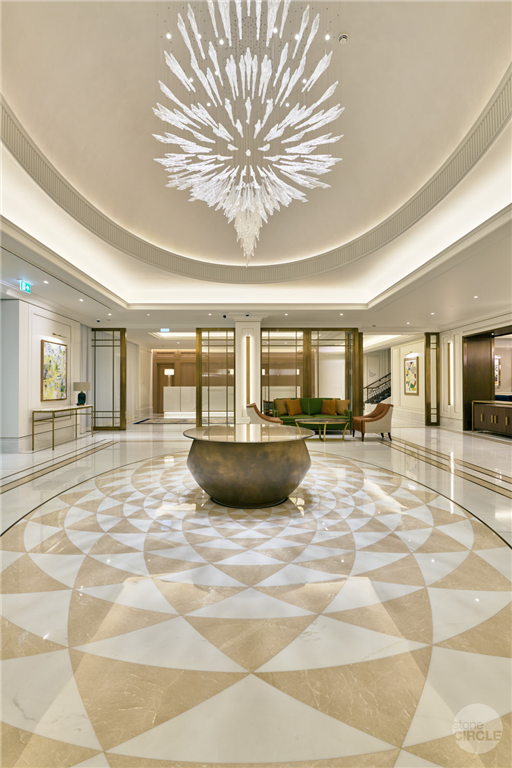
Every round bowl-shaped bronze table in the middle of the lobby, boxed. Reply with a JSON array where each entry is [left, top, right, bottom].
[[183, 424, 315, 509]]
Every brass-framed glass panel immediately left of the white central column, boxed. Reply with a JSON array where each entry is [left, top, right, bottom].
[[196, 328, 235, 426]]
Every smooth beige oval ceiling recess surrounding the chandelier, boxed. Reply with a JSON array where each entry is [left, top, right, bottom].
[[1, 0, 511, 265]]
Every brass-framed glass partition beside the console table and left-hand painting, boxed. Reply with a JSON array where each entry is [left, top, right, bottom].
[[92, 328, 126, 429]]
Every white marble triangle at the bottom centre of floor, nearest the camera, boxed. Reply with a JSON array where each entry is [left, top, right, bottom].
[[108, 675, 392, 764]]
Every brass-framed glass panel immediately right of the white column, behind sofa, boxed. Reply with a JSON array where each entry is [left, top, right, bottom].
[[261, 328, 304, 413]]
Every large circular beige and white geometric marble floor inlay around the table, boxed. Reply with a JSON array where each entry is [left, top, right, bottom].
[[0, 453, 512, 768]]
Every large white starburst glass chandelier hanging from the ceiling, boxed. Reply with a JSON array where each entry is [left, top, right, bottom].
[[154, 0, 344, 264]]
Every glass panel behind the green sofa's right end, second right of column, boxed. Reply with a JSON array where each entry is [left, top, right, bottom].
[[311, 329, 350, 400]]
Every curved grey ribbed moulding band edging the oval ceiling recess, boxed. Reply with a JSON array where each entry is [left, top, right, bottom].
[[0, 65, 512, 284]]
